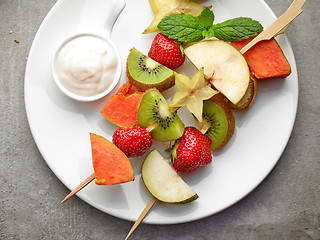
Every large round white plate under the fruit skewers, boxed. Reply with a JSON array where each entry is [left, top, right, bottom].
[[25, 0, 298, 224]]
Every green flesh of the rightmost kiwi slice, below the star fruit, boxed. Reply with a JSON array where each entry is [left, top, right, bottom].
[[201, 101, 233, 150]]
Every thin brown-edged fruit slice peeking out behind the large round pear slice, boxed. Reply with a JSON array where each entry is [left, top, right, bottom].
[[229, 76, 258, 110]]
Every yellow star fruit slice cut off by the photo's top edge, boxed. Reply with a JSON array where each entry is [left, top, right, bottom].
[[143, 0, 208, 34]]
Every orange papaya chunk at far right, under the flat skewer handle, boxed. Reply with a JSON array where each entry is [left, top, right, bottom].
[[231, 37, 291, 79]]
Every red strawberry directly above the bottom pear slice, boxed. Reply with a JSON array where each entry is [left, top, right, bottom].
[[171, 127, 212, 173]]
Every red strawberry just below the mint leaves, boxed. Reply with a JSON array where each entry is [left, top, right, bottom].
[[148, 33, 185, 69]]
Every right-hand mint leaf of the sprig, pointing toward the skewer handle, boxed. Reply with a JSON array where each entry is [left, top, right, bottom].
[[210, 17, 263, 42]]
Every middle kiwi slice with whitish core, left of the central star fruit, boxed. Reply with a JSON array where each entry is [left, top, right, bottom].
[[137, 89, 184, 142]]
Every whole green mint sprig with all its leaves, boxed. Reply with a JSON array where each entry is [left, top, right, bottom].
[[158, 8, 263, 42]]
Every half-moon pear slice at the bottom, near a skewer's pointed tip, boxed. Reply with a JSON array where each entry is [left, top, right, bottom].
[[141, 150, 198, 203]]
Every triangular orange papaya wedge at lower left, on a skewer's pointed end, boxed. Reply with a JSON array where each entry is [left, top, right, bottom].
[[90, 133, 134, 185]]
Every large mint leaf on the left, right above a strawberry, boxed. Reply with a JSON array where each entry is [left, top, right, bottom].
[[158, 13, 203, 42]]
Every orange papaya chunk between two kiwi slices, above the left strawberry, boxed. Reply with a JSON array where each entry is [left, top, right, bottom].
[[101, 83, 143, 127]]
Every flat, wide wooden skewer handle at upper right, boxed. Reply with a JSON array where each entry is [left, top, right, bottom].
[[240, 6, 302, 54]]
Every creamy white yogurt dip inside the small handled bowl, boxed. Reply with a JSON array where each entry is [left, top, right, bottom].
[[54, 35, 118, 96]]
